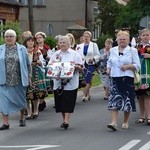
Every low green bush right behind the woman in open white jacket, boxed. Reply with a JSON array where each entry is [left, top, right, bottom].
[[96, 34, 112, 49]]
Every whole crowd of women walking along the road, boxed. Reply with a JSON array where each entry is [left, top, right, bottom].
[[0, 29, 150, 131]]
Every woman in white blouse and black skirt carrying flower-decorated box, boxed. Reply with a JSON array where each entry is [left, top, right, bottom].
[[49, 36, 82, 129]]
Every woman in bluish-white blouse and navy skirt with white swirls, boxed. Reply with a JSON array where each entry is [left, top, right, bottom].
[[107, 31, 141, 131]]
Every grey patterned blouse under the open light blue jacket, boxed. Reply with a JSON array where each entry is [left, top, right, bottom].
[[5, 46, 21, 86]]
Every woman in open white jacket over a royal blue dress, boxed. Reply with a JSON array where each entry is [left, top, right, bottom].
[[77, 31, 100, 102]]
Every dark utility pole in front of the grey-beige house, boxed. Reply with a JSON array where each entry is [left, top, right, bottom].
[[28, 0, 34, 35]]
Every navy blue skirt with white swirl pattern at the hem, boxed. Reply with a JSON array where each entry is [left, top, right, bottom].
[[108, 77, 136, 112]]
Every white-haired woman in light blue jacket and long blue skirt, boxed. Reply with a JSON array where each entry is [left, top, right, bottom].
[[0, 29, 31, 130]]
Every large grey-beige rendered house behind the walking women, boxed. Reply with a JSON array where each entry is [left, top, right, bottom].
[[19, 0, 100, 38]]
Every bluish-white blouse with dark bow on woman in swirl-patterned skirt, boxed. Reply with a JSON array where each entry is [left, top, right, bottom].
[[107, 46, 141, 77]]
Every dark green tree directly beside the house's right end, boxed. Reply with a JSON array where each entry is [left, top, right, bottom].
[[98, 0, 121, 36]]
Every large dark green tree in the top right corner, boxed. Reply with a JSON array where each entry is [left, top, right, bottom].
[[115, 0, 150, 34]]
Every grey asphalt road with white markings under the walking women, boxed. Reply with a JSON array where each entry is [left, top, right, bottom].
[[0, 87, 150, 150]]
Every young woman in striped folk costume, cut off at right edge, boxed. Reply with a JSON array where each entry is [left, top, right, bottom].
[[135, 29, 150, 125]]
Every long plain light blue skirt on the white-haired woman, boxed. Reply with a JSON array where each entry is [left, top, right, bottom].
[[0, 84, 27, 115]]
